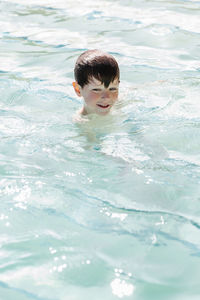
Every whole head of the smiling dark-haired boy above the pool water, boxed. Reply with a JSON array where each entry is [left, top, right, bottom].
[[72, 50, 120, 115]]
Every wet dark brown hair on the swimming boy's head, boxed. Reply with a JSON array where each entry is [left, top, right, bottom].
[[74, 50, 120, 88]]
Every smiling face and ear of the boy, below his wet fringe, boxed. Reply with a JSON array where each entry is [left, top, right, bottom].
[[73, 77, 119, 115]]
